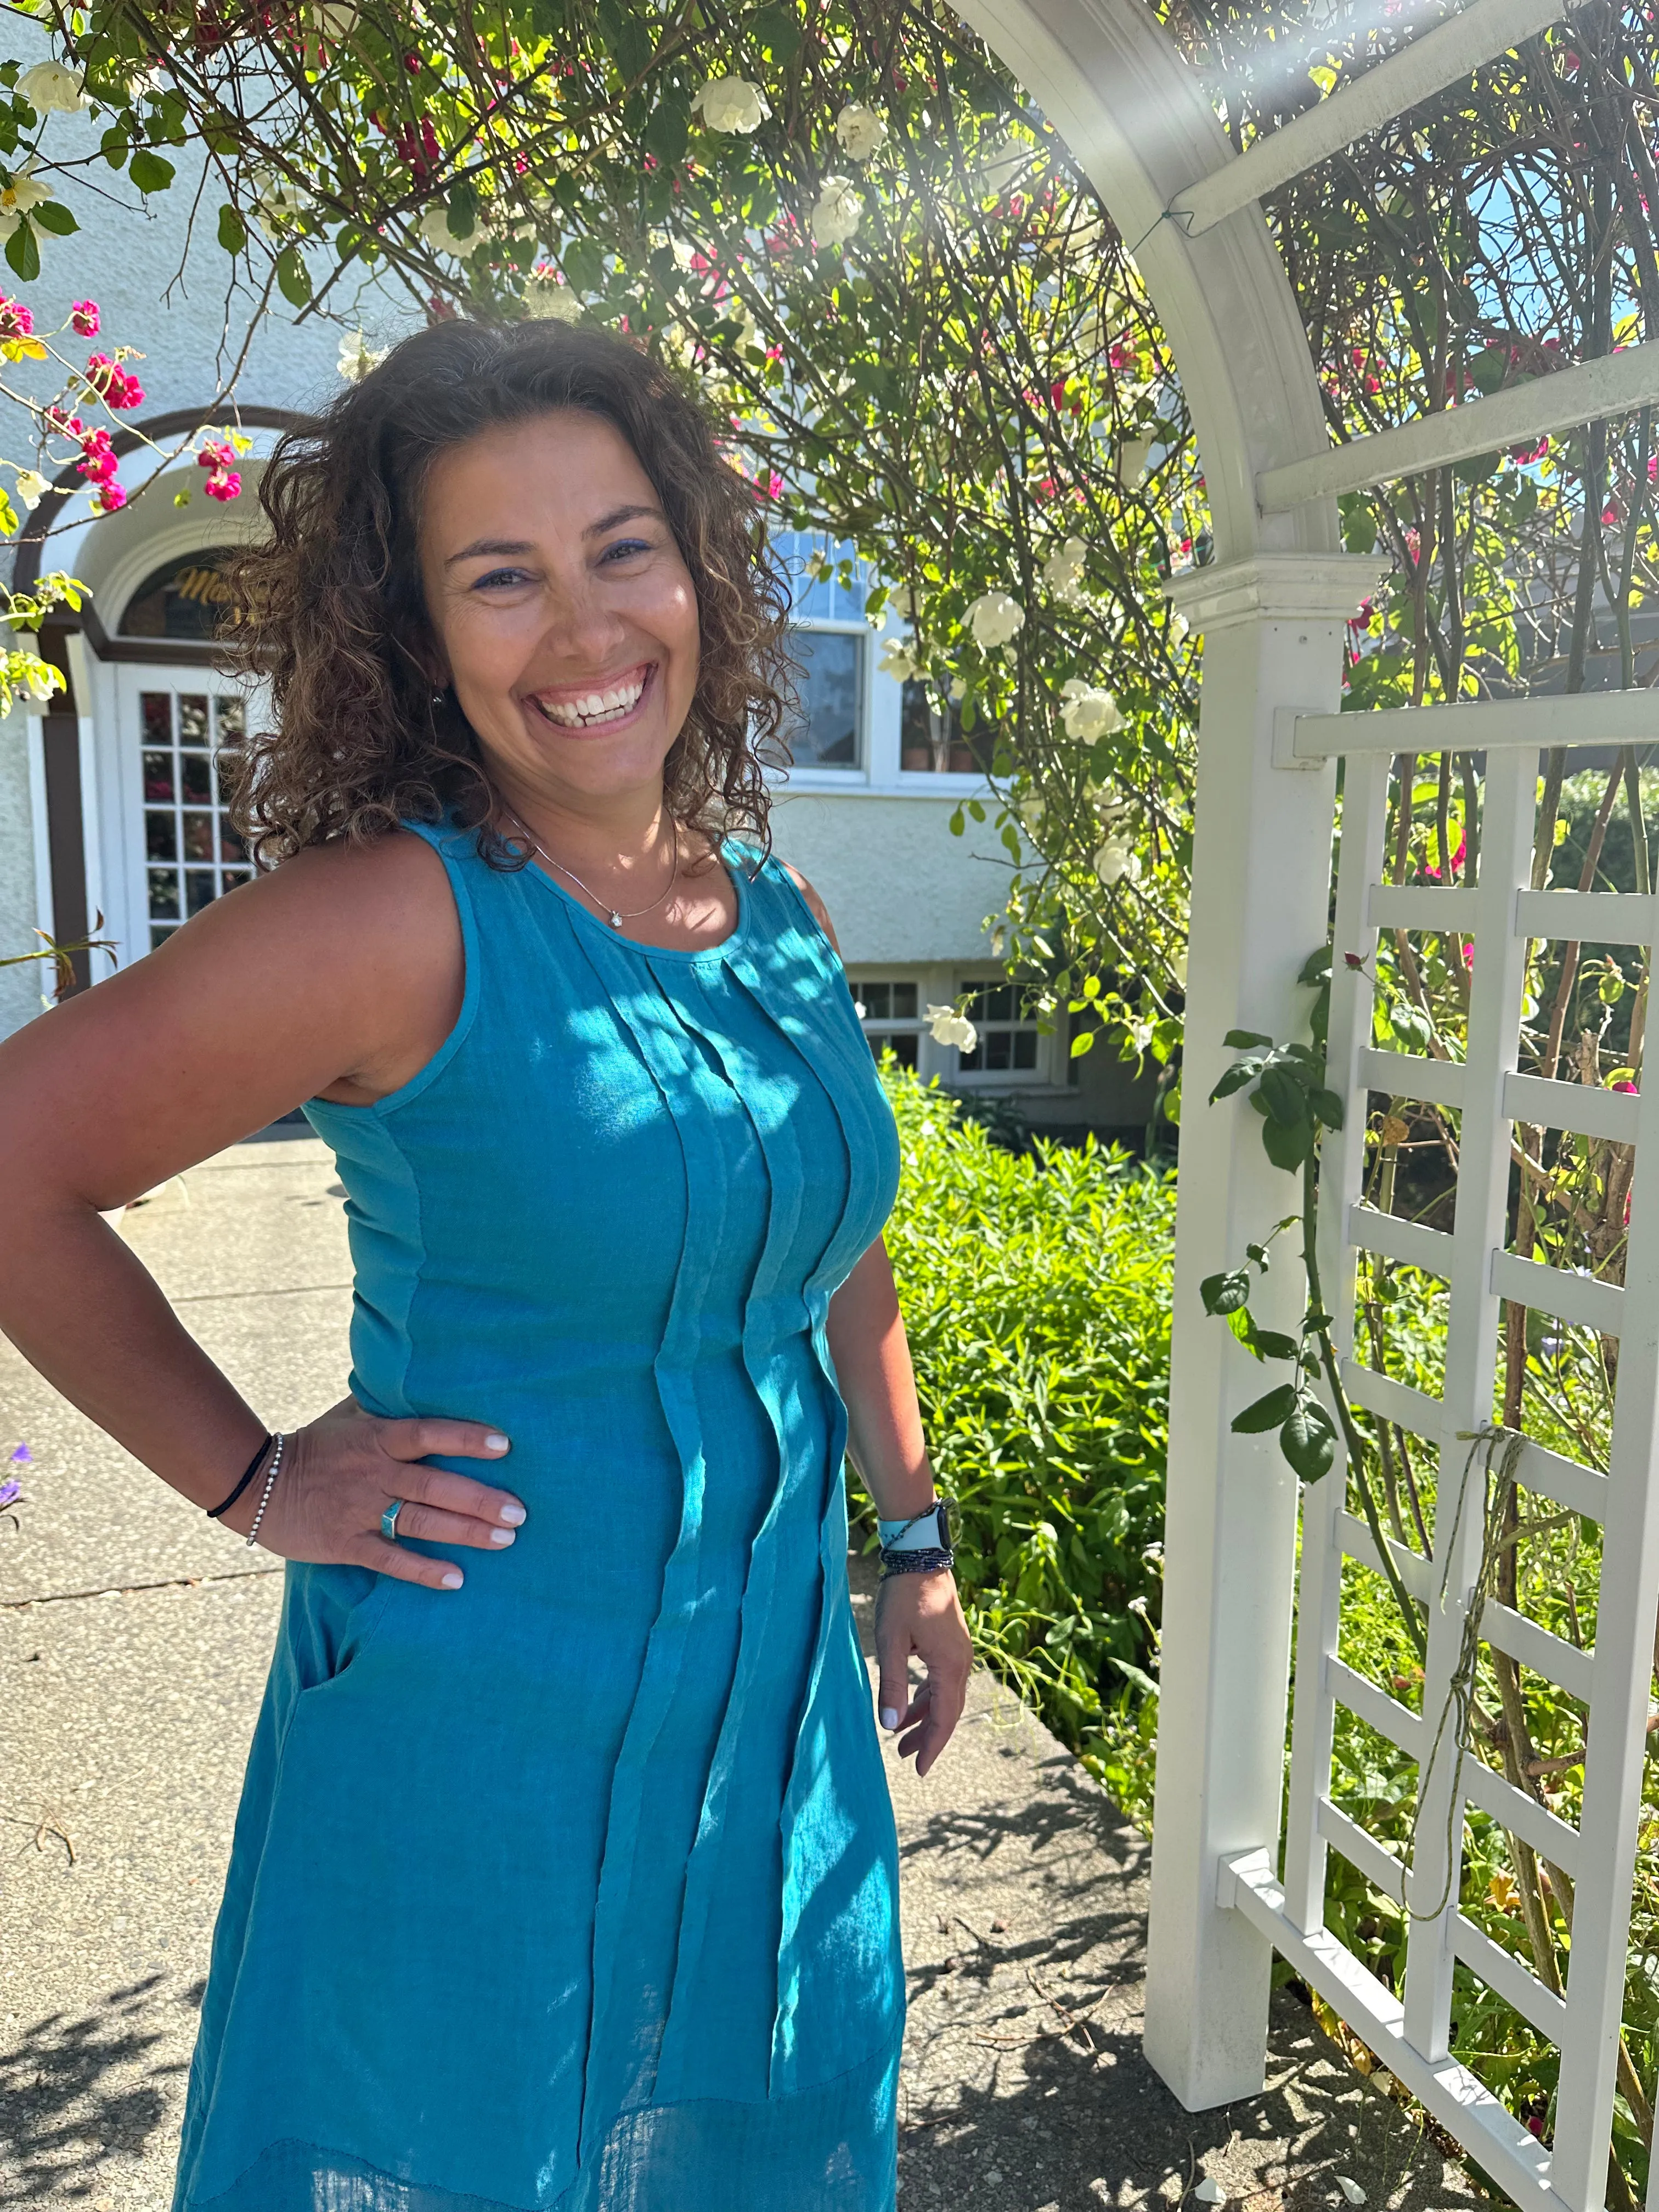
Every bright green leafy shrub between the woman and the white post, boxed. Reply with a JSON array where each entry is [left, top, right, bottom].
[[885, 1062, 1175, 1820]]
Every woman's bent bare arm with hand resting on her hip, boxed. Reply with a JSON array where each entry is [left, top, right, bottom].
[[0, 838, 526, 1579]]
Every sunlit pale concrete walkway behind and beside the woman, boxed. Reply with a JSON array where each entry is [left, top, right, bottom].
[[0, 1139, 1480, 2212]]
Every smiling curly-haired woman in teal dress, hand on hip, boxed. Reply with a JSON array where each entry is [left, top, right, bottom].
[[0, 323, 969, 2212]]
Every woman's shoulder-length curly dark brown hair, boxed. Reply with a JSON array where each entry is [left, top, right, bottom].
[[221, 321, 789, 867]]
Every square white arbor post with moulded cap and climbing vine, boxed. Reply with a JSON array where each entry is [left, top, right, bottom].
[[1146, 553, 1378, 2113]]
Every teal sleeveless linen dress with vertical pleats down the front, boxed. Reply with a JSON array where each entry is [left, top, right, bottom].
[[175, 825, 905, 2212]]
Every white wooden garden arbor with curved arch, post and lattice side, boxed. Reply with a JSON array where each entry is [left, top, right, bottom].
[[964, 0, 1659, 2212]]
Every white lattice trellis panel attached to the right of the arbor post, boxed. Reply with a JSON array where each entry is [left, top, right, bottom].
[[1223, 725, 1659, 2212]]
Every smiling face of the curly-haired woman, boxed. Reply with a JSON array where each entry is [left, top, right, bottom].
[[420, 409, 697, 812]]
